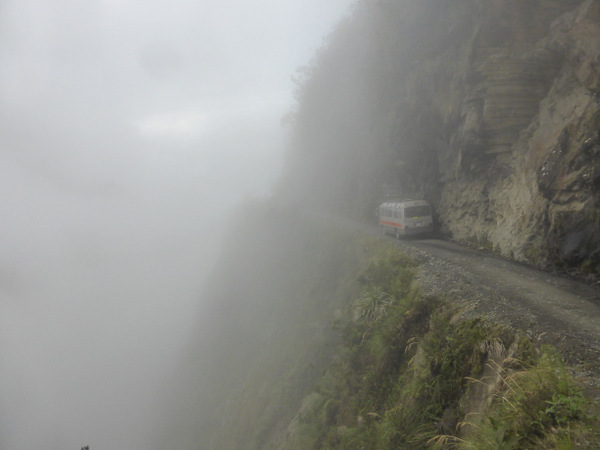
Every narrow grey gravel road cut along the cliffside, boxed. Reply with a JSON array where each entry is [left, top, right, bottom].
[[315, 214, 600, 384]]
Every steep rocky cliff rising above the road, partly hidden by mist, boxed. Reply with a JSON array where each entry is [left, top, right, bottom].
[[281, 0, 600, 275]]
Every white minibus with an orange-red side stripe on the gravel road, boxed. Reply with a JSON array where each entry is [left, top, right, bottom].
[[378, 200, 433, 238]]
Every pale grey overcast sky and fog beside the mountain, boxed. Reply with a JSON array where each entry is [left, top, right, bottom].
[[0, 0, 351, 450]]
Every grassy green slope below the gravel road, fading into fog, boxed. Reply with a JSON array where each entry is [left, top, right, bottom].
[[156, 202, 600, 449]]
